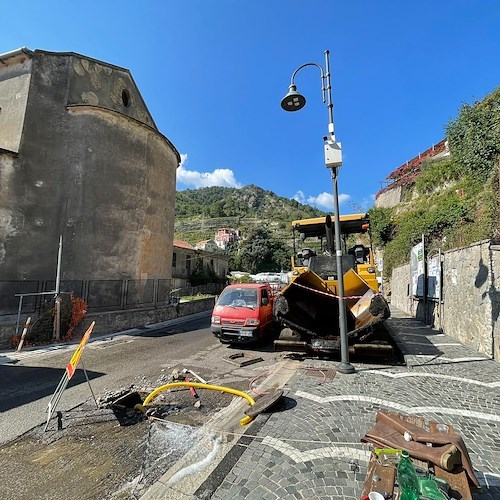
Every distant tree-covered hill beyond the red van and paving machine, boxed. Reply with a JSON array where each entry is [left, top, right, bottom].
[[175, 185, 326, 273]]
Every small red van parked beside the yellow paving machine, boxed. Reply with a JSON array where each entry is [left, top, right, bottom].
[[211, 283, 274, 344]]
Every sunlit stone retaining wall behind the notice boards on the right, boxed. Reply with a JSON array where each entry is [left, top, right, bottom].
[[390, 240, 500, 361]]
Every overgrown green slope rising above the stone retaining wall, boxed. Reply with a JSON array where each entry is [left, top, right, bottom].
[[370, 88, 500, 277]]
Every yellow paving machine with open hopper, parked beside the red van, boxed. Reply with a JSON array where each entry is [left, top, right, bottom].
[[273, 213, 392, 355]]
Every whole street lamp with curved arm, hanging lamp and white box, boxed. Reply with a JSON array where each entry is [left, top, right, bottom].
[[281, 50, 355, 373]]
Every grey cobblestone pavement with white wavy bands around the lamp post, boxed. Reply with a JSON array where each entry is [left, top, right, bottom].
[[208, 310, 500, 500]]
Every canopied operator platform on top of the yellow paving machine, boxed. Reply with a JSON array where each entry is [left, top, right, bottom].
[[292, 213, 379, 291]]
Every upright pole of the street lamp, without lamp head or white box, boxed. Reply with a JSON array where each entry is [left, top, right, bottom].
[[323, 50, 356, 374]]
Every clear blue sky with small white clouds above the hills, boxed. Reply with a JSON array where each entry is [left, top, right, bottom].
[[0, 0, 500, 213]]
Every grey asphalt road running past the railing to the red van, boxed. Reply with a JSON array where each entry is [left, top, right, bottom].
[[0, 312, 282, 443]]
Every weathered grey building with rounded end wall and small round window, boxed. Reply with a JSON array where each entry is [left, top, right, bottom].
[[0, 48, 180, 315]]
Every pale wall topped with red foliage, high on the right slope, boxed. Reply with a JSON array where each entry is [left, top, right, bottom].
[[375, 139, 450, 208]]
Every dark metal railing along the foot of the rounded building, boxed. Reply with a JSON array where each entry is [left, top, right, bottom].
[[0, 279, 177, 316]]
